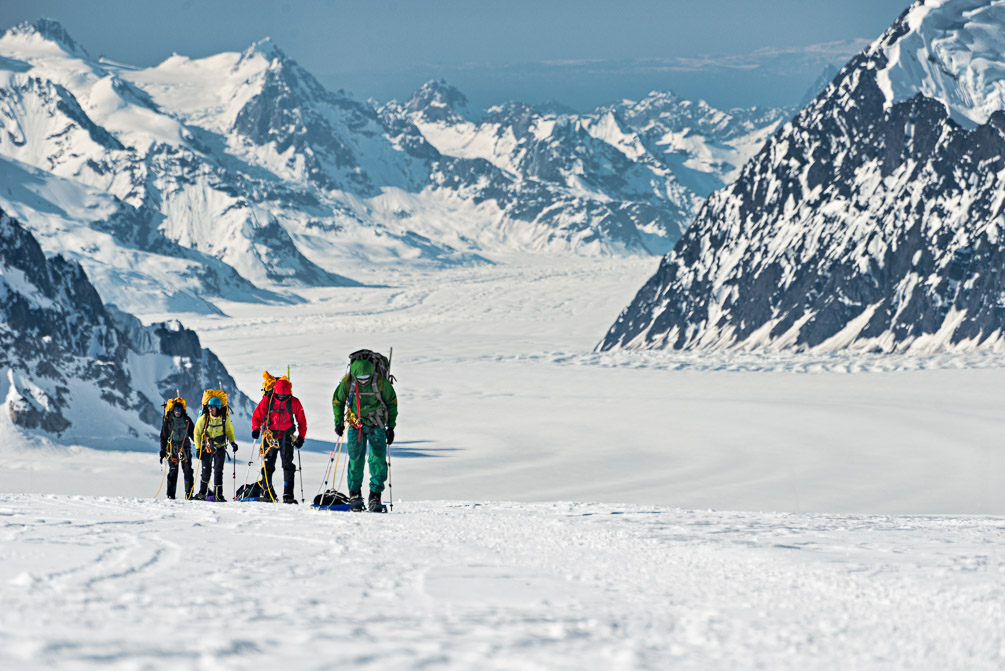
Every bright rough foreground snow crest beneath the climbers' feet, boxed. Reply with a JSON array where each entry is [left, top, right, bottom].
[[0, 494, 1005, 669]]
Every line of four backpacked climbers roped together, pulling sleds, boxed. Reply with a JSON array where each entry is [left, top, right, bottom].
[[155, 350, 398, 512]]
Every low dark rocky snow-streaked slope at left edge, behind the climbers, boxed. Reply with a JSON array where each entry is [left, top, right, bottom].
[[0, 210, 251, 449]]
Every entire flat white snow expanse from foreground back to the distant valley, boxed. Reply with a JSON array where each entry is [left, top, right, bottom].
[[0, 257, 1005, 671]]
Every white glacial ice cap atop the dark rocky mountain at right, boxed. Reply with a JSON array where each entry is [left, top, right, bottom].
[[868, 0, 1005, 128]]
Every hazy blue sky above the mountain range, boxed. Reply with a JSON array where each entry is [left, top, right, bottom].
[[0, 0, 909, 109]]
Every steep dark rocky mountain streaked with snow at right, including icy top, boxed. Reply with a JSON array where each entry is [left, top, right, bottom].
[[600, 0, 1005, 352]]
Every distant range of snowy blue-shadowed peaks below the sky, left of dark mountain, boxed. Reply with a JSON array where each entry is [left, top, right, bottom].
[[0, 20, 788, 313]]
